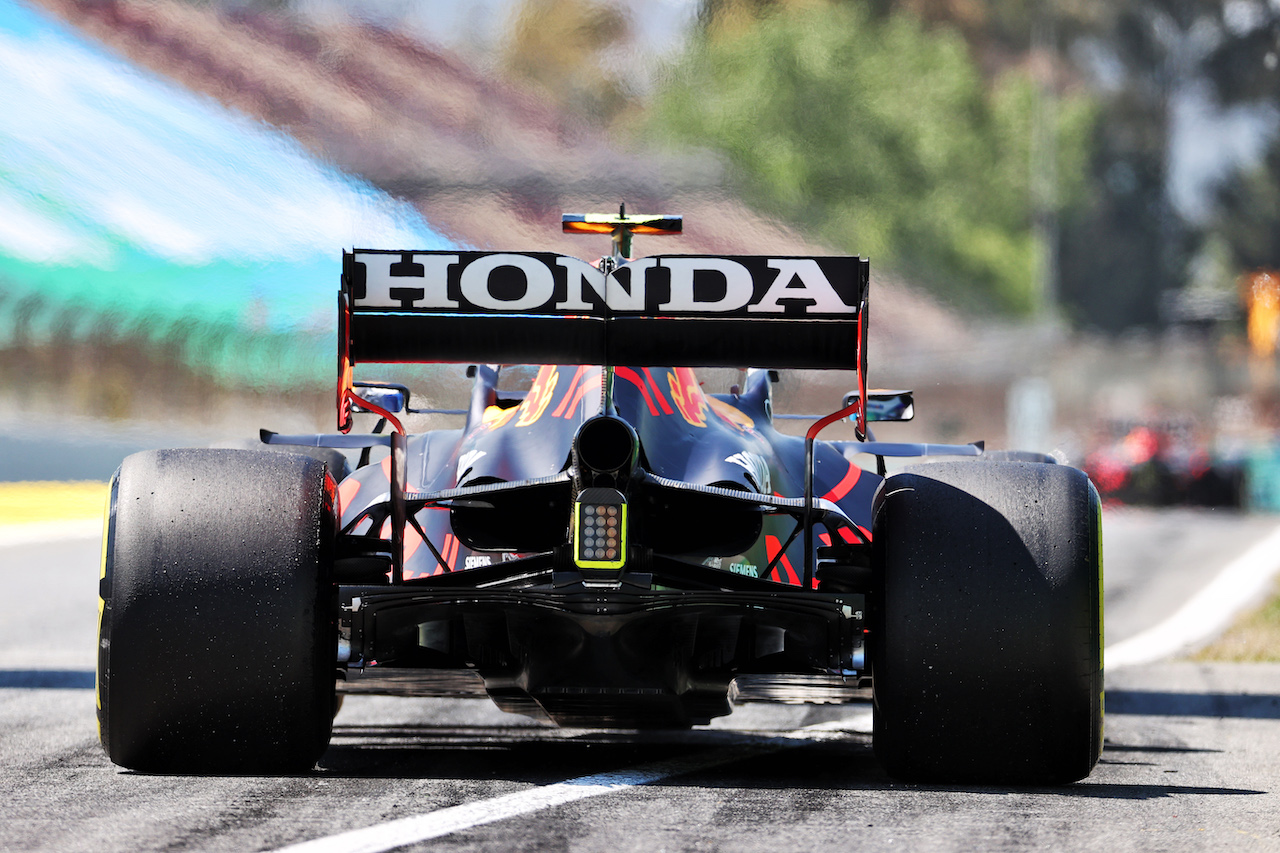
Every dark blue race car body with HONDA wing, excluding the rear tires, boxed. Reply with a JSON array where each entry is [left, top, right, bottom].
[[272, 214, 979, 726]]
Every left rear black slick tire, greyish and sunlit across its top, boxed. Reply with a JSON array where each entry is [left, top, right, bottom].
[[97, 450, 337, 774]]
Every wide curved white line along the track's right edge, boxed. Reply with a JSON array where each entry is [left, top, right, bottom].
[[1106, 528, 1280, 670]]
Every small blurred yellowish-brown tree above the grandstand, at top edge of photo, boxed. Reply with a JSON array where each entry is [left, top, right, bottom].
[[502, 0, 632, 126]]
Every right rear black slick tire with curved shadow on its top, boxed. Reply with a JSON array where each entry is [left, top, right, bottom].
[[869, 462, 1102, 785]]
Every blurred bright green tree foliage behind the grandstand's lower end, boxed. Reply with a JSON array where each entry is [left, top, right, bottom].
[[648, 0, 1092, 313]]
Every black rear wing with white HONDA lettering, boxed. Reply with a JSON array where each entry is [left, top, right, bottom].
[[339, 248, 869, 370]]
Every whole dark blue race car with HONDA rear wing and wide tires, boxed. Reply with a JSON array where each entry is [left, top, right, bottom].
[[97, 209, 1102, 784]]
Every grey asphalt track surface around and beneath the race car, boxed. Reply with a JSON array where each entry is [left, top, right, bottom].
[[0, 511, 1280, 853]]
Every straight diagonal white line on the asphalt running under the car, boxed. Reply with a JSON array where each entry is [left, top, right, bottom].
[[268, 711, 870, 853]]
